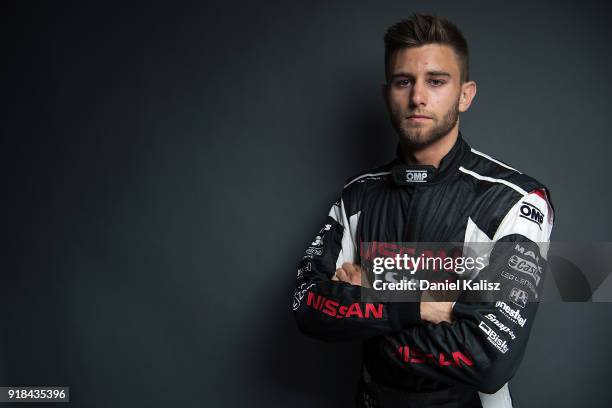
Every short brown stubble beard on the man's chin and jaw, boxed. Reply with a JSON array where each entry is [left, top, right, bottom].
[[393, 100, 459, 149]]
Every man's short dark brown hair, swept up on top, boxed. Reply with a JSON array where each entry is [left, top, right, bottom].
[[385, 14, 470, 83]]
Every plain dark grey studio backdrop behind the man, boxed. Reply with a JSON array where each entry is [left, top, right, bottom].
[[0, 1, 612, 407]]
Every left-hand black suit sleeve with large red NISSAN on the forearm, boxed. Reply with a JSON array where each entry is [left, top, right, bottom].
[[292, 194, 421, 341]]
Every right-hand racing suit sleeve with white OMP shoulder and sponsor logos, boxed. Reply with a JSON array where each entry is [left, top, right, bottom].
[[381, 190, 553, 393]]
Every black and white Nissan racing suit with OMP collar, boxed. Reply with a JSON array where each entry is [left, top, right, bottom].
[[292, 133, 553, 408]]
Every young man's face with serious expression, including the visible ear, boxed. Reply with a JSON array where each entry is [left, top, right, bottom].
[[385, 44, 476, 148]]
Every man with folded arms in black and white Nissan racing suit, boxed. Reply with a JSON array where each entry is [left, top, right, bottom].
[[293, 15, 553, 408]]
